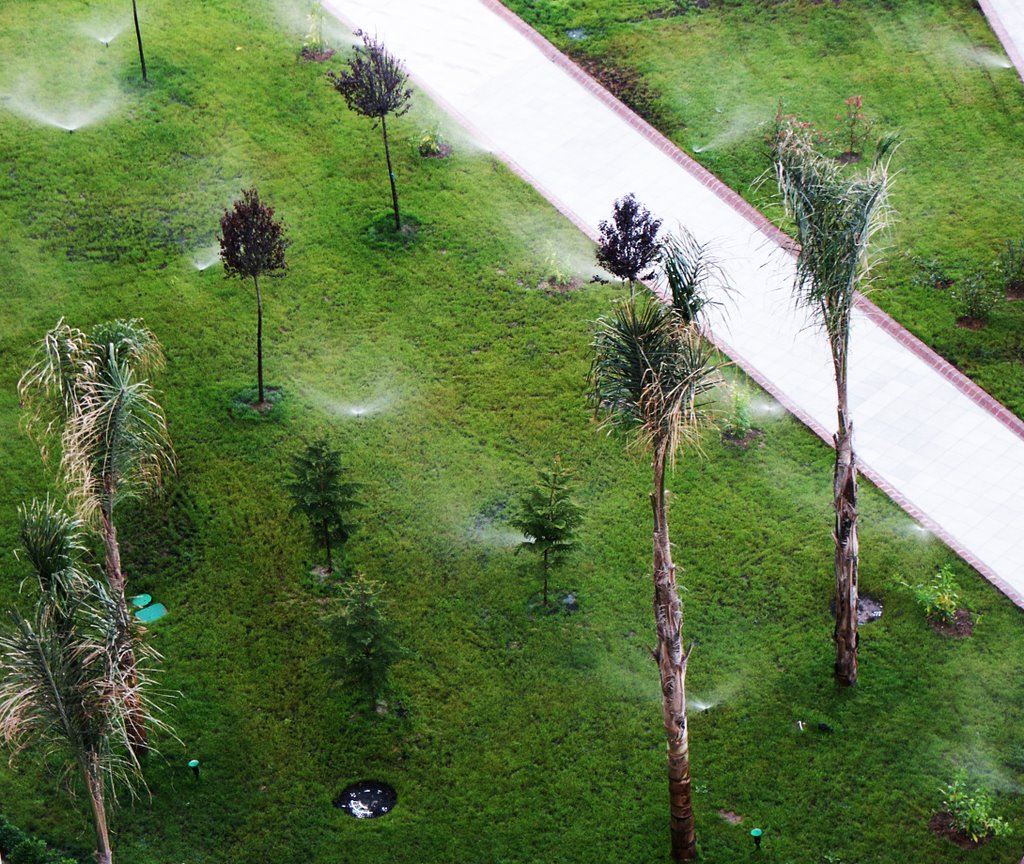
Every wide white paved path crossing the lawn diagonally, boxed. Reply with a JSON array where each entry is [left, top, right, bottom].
[[325, 0, 1024, 606]]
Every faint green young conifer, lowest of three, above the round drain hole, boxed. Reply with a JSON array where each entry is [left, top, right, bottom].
[[324, 573, 401, 700]]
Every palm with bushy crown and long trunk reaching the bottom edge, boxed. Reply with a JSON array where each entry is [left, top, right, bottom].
[[591, 299, 719, 861]]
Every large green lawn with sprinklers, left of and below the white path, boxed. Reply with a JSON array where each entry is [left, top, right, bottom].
[[0, 0, 1024, 864]]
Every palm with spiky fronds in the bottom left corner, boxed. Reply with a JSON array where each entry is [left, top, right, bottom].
[[0, 502, 163, 864]]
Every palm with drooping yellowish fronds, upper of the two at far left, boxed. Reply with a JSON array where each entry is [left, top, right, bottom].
[[18, 319, 174, 749]]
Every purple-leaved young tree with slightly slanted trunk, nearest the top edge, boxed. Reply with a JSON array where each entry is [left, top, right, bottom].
[[327, 34, 413, 231]]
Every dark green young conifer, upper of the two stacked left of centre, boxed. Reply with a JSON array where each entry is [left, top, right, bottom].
[[288, 438, 361, 571]]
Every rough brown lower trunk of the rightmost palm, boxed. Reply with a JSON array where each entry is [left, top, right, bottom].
[[833, 399, 859, 687]]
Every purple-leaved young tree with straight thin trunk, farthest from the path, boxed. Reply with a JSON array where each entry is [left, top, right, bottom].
[[220, 188, 288, 406]]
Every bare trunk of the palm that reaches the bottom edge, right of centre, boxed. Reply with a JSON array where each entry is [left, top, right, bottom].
[[650, 445, 696, 861]]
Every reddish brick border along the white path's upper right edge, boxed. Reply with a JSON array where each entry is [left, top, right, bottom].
[[480, 0, 1024, 443]]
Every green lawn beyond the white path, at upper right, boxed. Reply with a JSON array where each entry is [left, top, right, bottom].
[[507, 0, 1024, 416]]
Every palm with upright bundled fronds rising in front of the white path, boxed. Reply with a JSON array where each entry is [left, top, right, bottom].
[[772, 118, 896, 687]]
